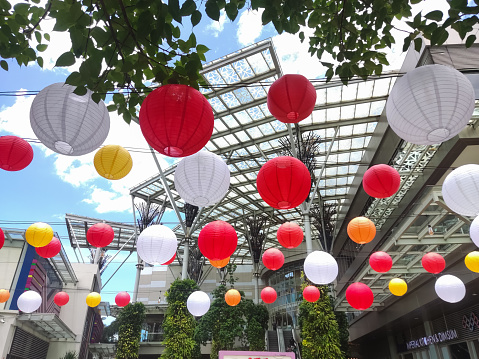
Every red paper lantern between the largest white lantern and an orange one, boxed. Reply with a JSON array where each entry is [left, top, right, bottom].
[[363, 164, 401, 198]]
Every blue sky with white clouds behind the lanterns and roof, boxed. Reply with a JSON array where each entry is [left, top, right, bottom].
[[0, 0, 450, 303]]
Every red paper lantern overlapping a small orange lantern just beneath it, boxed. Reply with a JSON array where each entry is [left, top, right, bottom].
[[198, 221, 238, 261]]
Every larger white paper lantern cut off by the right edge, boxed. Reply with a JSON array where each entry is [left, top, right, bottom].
[[442, 164, 479, 216]]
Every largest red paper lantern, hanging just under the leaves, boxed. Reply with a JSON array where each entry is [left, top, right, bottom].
[[140, 85, 214, 157]]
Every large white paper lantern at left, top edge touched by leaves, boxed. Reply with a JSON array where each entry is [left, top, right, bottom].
[[30, 83, 110, 156]]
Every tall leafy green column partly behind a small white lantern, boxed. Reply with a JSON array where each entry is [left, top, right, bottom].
[[161, 279, 200, 359]]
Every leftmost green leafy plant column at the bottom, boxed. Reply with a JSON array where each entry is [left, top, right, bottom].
[[116, 302, 146, 359]]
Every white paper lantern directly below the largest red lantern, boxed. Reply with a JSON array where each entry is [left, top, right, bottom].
[[175, 151, 230, 207]]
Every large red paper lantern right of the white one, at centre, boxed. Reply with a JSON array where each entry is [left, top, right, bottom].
[[256, 156, 311, 209]]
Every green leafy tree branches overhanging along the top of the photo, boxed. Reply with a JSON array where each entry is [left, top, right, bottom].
[[0, 0, 479, 122]]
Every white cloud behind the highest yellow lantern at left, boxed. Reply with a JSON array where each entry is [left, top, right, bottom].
[[0, 96, 172, 213]]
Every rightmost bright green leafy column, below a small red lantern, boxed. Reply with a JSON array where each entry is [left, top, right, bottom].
[[299, 283, 344, 359]]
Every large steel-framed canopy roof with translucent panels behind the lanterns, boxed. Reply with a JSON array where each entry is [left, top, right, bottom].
[[126, 40, 479, 311]]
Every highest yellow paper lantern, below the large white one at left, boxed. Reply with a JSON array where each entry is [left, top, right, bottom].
[[93, 145, 133, 180]]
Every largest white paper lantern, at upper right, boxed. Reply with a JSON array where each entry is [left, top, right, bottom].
[[386, 65, 475, 145]]
